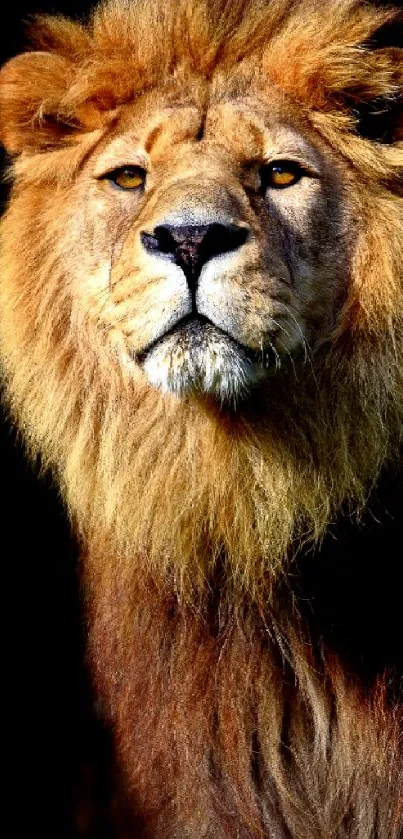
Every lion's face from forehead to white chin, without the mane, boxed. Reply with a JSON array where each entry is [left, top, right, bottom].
[[66, 83, 351, 402]]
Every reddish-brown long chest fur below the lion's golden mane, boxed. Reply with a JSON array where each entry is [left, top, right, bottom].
[[86, 553, 403, 839]]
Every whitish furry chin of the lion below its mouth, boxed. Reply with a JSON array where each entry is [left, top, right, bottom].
[[139, 320, 268, 405]]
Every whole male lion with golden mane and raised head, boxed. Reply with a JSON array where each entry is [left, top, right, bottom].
[[0, 0, 403, 839]]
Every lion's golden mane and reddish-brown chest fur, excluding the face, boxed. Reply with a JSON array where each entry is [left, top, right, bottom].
[[0, 0, 403, 839]]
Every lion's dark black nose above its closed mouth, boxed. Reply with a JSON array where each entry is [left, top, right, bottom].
[[141, 223, 248, 287]]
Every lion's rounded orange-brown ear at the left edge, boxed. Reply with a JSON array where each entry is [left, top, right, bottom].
[[0, 52, 77, 155]]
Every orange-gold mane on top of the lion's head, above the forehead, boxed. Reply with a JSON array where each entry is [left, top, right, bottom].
[[3, 0, 402, 124]]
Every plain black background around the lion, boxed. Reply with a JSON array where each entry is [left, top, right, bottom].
[[0, 0, 402, 839]]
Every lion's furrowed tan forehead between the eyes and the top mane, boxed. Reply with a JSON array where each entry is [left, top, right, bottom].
[[94, 89, 326, 176]]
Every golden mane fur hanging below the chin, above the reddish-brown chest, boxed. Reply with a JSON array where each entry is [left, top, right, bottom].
[[75, 360, 396, 597]]
